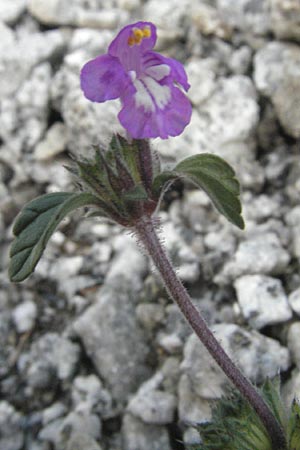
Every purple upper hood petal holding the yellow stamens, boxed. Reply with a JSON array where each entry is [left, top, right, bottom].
[[108, 22, 157, 74]]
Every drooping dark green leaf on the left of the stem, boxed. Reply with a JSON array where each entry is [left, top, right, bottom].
[[9, 192, 101, 282]]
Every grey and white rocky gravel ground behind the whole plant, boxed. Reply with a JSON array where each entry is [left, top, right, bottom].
[[0, 0, 300, 450]]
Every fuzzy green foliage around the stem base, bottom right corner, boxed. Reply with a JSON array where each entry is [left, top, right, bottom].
[[190, 377, 300, 450]]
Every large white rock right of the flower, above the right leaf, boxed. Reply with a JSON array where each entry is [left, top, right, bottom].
[[158, 75, 260, 186]]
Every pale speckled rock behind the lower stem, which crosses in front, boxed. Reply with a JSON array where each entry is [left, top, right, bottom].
[[181, 324, 290, 408]]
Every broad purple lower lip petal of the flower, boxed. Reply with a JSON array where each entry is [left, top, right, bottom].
[[118, 85, 192, 139]]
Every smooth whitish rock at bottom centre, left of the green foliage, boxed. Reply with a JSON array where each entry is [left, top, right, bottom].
[[127, 386, 177, 425]]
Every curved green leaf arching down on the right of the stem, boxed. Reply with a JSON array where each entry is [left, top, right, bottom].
[[173, 153, 245, 229]]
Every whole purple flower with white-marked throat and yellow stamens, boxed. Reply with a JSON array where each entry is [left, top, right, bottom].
[[80, 22, 192, 139]]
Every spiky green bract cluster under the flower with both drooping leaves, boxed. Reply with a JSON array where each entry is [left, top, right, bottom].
[[9, 136, 244, 282]]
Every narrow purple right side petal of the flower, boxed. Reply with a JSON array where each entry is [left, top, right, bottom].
[[143, 52, 190, 91]]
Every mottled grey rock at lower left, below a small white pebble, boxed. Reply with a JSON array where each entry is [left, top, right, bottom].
[[19, 333, 80, 388]]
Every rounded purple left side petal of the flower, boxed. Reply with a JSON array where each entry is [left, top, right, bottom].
[[80, 55, 130, 103]]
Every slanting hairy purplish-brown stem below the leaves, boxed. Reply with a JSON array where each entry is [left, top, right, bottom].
[[134, 216, 287, 450]]
